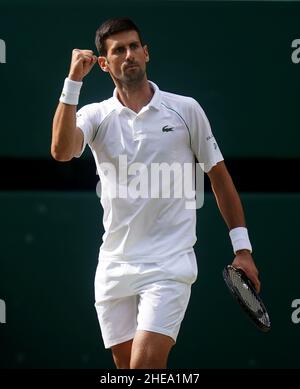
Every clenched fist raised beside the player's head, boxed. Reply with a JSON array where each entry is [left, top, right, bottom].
[[68, 49, 97, 81]]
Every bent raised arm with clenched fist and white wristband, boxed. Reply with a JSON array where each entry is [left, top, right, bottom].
[[51, 49, 97, 161]]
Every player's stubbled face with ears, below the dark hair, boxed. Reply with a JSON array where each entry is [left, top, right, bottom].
[[98, 31, 149, 84]]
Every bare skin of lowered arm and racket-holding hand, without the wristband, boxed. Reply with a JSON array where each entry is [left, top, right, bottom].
[[207, 161, 260, 291]]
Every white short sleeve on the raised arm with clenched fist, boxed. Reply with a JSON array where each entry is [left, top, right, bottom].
[[75, 103, 99, 158]]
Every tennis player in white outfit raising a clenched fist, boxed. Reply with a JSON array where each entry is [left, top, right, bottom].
[[51, 18, 260, 368]]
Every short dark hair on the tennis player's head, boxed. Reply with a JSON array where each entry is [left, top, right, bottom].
[[95, 17, 143, 56]]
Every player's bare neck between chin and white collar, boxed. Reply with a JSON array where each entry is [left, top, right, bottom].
[[115, 77, 154, 113]]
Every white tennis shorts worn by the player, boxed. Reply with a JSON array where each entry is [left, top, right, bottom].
[[95, 251, 197, 348]]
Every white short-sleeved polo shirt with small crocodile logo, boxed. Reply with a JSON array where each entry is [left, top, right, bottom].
[[77, 81, 223, 262]]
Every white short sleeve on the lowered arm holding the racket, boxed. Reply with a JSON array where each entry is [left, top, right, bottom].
[[189, 99, 224, 173]]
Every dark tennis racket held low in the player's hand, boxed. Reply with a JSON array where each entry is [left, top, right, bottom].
[[223, 265, 271, 332]]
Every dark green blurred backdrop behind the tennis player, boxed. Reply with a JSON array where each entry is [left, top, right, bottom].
[[0, 0, 300, 368]]
